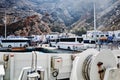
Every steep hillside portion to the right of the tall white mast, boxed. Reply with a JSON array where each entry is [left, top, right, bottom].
[[97, 0, 120, 31]]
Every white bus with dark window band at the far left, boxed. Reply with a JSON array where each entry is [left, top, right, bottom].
[[0, 38, 30, 48]]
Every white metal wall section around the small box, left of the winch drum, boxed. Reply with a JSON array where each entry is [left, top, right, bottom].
[[48, 53, 72, 80]]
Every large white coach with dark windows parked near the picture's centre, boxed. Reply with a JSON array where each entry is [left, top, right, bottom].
[[56, 37, 84, 51]]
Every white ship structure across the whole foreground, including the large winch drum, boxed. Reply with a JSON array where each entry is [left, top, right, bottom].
[[0, 49, 120, 80]]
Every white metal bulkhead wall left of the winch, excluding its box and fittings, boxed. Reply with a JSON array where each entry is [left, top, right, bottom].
[[0, 52, 72, 80]]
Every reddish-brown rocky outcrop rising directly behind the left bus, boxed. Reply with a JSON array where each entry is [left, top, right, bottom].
[[0, 15, 51, 36]]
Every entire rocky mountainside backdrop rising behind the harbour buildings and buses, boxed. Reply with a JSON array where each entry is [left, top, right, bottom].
[[0, 0, 119, 36]]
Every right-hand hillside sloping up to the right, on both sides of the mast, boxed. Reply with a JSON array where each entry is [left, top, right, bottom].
[[70, 0, 120, 35]]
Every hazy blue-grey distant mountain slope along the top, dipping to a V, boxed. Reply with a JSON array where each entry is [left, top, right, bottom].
[[0, 0, 116, 26]]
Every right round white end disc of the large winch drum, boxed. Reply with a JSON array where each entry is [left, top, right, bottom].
[[90, 50, 117, 80]]
